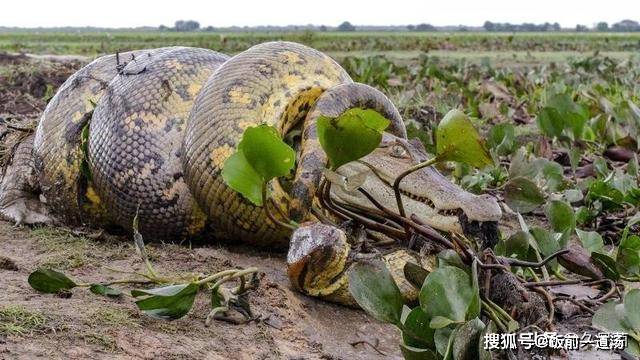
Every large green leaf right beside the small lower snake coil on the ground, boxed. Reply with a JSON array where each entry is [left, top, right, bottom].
[[349, 261, 403, 325]]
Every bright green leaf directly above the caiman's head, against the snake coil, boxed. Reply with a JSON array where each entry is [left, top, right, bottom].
[[317, 108, 390, 170]]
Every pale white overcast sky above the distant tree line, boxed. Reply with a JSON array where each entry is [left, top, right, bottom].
[[0, 0, 640, 27]]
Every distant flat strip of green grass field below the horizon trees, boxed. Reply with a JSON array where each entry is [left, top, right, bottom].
[[0, 31, 640, 55]]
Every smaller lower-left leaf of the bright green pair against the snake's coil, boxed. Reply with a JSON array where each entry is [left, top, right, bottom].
[[222, 151, 264, 206]]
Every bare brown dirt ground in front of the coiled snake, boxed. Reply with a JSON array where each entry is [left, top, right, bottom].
[[0, 222, 400, 359]]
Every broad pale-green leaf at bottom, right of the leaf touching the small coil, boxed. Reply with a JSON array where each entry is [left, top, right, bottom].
[[419, 266, 474, 322]]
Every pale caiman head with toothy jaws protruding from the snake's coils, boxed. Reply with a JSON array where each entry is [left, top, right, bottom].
[[331, 134, 502, 246]]
